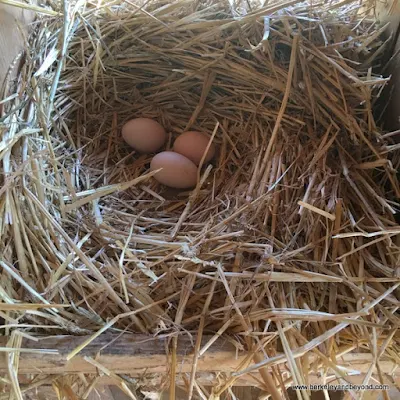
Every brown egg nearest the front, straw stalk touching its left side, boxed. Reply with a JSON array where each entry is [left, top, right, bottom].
[[150, 151, 197, 189]]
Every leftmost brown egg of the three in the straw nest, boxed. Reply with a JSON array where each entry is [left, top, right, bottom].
[[122, 118, 167, 153]]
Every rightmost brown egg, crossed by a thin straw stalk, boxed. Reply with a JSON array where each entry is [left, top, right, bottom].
[[173, 131, 215, 165]]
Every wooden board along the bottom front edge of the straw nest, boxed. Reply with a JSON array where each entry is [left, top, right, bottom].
[[0, 334, 400, 379]]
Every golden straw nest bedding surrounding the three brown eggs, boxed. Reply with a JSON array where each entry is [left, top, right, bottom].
[[0, 0, 400, 398]]
